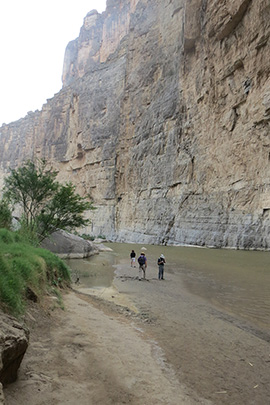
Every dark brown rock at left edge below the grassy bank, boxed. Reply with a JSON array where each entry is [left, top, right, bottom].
[[0, 312, 29, 386]]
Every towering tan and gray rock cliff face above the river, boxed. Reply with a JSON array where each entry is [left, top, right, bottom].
[[0, 0, 270, 249]]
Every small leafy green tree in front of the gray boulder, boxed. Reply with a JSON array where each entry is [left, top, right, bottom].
[[4, 160, 94, 242]]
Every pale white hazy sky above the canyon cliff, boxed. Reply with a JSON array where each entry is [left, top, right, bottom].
[[0, 0, 106, 125]]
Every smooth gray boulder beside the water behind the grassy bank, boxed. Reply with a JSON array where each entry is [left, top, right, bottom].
[[42, 230, 99, 259]]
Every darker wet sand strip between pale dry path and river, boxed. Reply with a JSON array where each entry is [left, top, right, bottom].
[[116, 258, 270, 404]]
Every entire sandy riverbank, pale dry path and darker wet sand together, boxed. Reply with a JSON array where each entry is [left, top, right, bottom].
[[5, 262, 270, 405]]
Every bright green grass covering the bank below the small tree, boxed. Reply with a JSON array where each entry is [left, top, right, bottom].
[[0, 229, 70, 316]]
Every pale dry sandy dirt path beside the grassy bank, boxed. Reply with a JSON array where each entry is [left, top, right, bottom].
[[5, 292, 198, 405]]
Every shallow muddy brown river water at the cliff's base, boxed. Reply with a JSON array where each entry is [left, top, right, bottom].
[[67, 243, 270, 331]]
